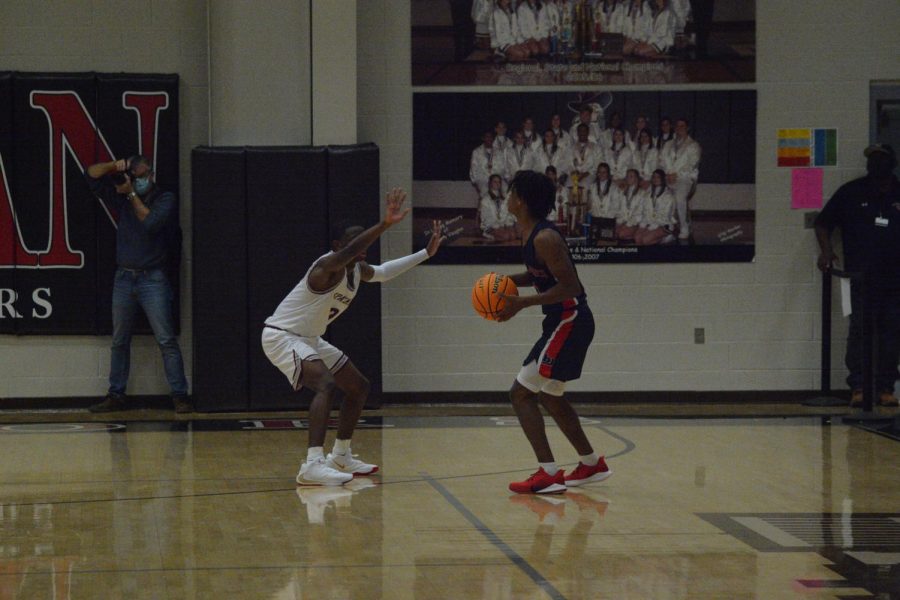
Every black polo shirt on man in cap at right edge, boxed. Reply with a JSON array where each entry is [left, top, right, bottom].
[[816, 177, 900, 283]]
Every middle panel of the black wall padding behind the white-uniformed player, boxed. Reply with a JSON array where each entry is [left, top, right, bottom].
[[247, 147, 328, 409]]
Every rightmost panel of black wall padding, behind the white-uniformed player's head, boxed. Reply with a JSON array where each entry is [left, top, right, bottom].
[[327, 144, 382, 408]]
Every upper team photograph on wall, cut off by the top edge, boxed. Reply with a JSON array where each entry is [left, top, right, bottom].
[[411, 0, 756, 86]]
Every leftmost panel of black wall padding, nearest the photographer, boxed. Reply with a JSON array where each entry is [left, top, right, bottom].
[[191, 148, 250, 411]]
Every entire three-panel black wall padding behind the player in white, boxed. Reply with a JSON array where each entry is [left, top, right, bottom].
[[192, 144, 381, 411]]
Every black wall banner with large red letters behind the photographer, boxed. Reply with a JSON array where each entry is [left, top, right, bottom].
[[0, 73, 179, 335]]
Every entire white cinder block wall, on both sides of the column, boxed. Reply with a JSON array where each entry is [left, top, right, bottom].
[[0, 0, 900, 399]]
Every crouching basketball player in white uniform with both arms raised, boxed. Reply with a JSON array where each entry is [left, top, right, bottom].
[[262, 188, 444, 485]]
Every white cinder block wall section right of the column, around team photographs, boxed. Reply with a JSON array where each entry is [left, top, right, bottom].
[[357, 0, 900, 392]]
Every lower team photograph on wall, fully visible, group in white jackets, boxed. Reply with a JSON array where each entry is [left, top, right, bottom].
[[412, 90, 757, 264]]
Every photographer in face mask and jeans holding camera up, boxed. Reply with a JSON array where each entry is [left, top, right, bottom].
[[85, 156, 193, 413]]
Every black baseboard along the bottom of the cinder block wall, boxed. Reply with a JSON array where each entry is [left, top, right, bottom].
[[0, 390, 850, 412]]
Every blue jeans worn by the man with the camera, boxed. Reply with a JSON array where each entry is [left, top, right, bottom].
[[109, 268, 187, 396]]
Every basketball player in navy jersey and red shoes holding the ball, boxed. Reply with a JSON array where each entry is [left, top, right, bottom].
[[497, 171, 612, 494]]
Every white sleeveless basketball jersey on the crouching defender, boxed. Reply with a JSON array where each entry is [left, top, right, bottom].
[[266, 252, 360, 337]]
